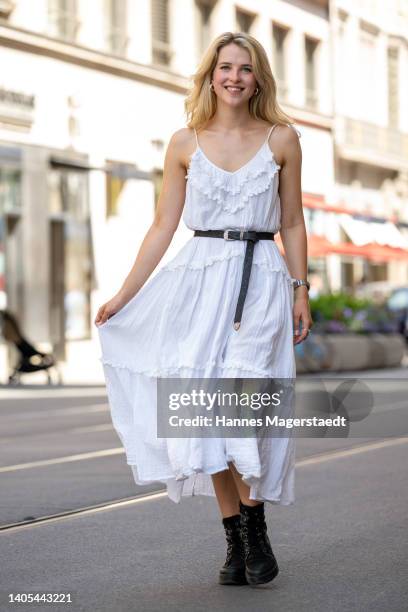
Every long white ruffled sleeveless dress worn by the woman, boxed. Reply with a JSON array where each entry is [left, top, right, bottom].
[[98, 126, 296, 505]]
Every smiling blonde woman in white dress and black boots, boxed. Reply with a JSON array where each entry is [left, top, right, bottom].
[[95, 32, 312, 585]]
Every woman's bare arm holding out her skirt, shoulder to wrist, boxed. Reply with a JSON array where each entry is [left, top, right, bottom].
[[118, 130, 186, 302]]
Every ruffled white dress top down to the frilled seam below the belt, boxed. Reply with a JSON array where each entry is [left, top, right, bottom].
[[159, 128, 291, 283]]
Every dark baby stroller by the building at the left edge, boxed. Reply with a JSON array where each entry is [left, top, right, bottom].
[[0, 310, 61, 384]]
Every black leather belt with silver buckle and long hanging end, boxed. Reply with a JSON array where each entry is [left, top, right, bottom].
[[194, 229, 275, 330]]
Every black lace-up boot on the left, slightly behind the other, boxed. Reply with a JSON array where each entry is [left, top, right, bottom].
[[219, 514, 248, 585]]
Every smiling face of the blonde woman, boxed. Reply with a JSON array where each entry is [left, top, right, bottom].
[[212, 43, 257, 106]]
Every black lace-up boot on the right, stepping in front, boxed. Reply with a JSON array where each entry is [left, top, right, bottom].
[[239, 502, 279, 586]]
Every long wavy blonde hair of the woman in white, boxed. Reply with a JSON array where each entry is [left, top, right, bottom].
[[184, 32, 294, 129]]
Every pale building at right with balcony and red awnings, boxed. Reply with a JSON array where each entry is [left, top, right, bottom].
[[324, 0, 408, 291]]
